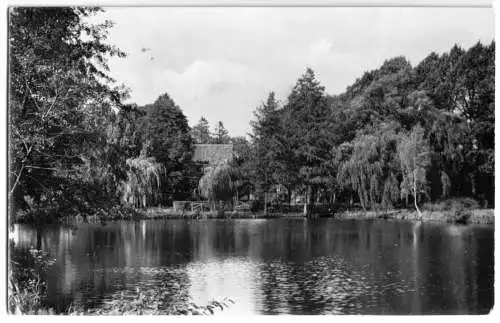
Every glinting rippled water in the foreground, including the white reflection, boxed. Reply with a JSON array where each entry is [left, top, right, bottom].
[[67, 256, 422, 314]]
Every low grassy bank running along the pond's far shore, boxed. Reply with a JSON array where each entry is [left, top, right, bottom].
[[13, 198, 495, 225]]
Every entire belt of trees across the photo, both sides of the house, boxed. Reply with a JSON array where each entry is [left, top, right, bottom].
[[8, 7, 495, 223]]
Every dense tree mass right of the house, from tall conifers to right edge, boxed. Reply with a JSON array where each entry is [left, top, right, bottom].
[[252, 42, 495, 215]]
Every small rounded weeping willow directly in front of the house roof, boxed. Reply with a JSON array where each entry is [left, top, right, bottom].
[[198, 162, 237, 209]]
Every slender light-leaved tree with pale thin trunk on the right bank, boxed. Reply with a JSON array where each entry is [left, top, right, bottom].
[[397, 125, 430, 219]]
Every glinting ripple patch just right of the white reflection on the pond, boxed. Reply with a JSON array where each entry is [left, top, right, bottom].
[[254, 257, 415, 314]]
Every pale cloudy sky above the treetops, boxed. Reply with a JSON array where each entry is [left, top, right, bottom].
[[101, 7, 494, 135]]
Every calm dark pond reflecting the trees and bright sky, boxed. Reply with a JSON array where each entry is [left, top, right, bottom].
[[9, 219, 494, 315]]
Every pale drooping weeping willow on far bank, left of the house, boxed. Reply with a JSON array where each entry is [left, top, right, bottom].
[[122, 156, 166, 208]]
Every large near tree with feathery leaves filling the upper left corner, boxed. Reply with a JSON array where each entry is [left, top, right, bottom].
[[8, 7, 125, 215]]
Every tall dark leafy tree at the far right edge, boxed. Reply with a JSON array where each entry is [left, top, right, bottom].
[[415, 42, 495, 206]]
